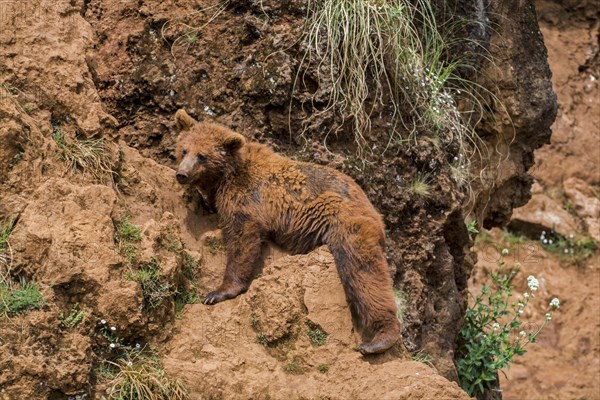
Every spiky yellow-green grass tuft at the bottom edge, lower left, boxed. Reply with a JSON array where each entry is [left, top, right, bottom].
[[98, 349, 189, 400]]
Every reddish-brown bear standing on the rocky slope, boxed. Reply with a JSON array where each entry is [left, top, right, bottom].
[[175, 110, 400, 354]]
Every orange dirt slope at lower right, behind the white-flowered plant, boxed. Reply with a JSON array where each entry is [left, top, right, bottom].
[[469, 230, 600, 400]]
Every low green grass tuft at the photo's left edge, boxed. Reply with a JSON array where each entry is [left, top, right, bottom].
[[0, 278, 46, 315]]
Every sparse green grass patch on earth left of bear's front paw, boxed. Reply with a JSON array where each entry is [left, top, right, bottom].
[[125, 259, 174, 309]]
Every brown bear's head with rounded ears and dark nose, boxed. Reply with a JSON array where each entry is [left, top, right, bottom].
[[175, 110, 246, 186]]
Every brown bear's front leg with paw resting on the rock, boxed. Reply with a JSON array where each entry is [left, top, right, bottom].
[[204, 218, 262, 305]]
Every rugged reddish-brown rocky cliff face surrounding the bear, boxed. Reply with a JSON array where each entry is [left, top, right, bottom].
[[0, 0, 556, 397]]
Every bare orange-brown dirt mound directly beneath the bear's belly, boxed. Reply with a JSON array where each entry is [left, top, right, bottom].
[[164, 248, 468, 399]]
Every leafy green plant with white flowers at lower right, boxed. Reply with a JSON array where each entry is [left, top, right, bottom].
[[456, 268, 560, 396]]
